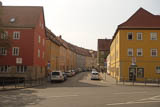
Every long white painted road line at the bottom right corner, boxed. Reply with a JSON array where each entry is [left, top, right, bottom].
[[106, 101, 160, 106]]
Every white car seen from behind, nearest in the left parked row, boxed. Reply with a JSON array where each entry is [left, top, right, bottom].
[[50, 71, 65, 82]]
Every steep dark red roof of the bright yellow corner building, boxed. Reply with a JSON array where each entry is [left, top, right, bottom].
[[118, 8, 160, 28]]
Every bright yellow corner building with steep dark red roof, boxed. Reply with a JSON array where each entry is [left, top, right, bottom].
[[110, 8, 160, 81]]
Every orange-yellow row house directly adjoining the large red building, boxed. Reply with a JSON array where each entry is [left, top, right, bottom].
[[45, 28, 61, 71]]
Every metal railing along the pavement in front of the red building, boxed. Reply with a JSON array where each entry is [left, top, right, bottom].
[[0, 78, 47, 90]]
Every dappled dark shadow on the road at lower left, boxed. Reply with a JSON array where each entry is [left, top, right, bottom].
[[0, 90, 44, 107]]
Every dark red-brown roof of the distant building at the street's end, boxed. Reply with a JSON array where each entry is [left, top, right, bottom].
[[98, 39, 111, 51]]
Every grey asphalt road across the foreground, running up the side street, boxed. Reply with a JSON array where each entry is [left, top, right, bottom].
[[0, 72, 160, 107]]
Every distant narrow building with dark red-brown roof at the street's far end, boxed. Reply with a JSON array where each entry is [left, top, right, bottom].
[[97, 39, 111, 71]]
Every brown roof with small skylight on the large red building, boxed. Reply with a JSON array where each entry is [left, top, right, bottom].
[[0, 6, 43, 28]]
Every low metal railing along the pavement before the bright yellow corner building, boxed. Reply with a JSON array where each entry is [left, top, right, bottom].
[[116, 77, 160, 87]]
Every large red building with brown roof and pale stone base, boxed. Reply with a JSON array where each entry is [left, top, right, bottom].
[[0, 6, 46, 79]]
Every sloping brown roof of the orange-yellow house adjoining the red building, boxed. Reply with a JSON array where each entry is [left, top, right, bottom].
[[46, 28, 61, 46]]
